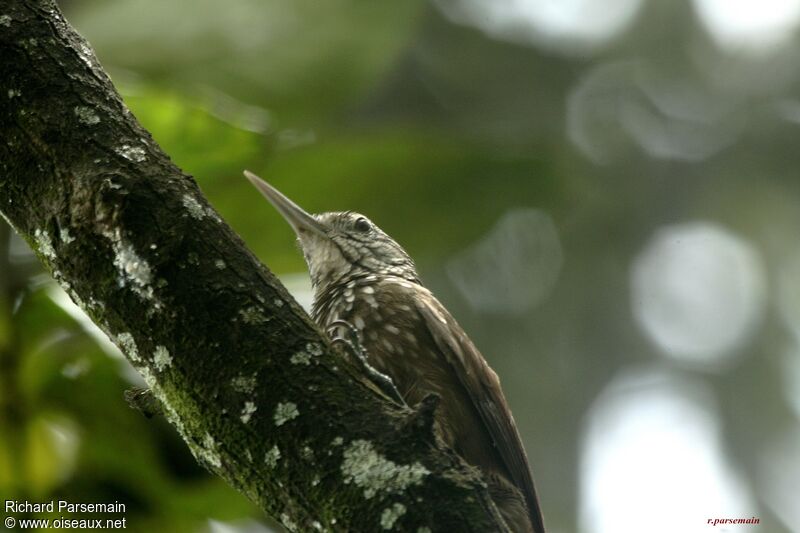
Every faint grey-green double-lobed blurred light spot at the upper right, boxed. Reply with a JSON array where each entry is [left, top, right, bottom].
[[567, 61, 743, 163]]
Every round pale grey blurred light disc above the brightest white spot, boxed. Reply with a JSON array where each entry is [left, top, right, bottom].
[[631, 222, 766, 364]]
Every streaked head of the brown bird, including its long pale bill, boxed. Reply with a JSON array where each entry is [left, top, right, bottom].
[[244, 171, 419, 289]]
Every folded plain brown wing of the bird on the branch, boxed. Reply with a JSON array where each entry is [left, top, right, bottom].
[[416, 295, 544, 533]]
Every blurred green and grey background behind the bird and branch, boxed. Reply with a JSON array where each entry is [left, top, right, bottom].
[[0, 0, 800, 533]]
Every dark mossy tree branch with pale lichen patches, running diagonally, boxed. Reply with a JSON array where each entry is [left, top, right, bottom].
[[0, 0, 510, 532]]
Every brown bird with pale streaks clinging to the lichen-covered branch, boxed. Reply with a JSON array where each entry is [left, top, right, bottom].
[[244, 171, 545, 533]]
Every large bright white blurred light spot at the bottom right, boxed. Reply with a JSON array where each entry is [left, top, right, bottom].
[[580, 368, 758, 533]]
